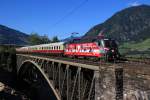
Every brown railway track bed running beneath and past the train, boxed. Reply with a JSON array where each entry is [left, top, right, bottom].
[[20, 54, 150, 66]]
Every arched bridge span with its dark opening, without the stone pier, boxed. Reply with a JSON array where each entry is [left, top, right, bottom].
[[17, 54, 98, 100]]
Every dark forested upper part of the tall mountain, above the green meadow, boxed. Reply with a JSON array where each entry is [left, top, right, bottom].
[[83, 5, 150, 43]]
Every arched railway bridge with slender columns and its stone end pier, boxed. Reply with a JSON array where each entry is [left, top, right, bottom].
[[17, 54, 123, 100]]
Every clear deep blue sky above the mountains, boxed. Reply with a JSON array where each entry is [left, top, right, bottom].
[[0, 0, 150, 39]]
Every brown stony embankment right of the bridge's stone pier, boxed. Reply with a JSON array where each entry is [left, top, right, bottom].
[[123, 64, 150, 100]]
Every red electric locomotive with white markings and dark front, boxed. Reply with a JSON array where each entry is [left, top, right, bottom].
[[64, 38, 120, 60]]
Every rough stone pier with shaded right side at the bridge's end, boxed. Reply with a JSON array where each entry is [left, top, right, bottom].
[[95, 65, 123, 100]]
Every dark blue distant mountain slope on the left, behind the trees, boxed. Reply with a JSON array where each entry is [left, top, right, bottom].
[[0, 25, 28, 45]]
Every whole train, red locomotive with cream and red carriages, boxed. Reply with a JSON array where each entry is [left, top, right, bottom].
[[16, 35, 120, 61]]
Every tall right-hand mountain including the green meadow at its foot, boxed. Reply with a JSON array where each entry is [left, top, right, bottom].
[[82, 5, 150, 56]]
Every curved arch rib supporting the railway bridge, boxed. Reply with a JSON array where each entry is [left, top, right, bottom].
[[17, 60, 61, 100]]
